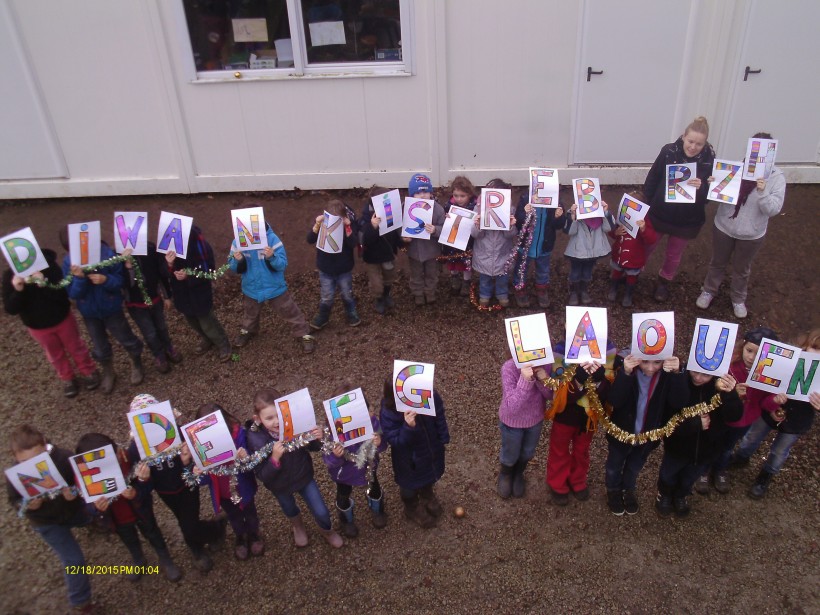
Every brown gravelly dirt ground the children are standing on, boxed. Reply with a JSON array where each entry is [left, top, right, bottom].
[[0, 186, 820, 613]]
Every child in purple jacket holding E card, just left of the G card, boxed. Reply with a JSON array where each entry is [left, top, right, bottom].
[[322, 387, 387, 538]]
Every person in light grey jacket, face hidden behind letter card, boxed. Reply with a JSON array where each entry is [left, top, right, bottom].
[[695, 132, 786, 318]]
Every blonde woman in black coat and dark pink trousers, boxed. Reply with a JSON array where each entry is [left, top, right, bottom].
[[643, 116, 715, 301]]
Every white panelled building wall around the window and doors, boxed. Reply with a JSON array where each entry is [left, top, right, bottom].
[[0, 0, 820, 198]]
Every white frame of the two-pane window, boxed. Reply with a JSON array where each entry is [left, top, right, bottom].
[[171, 0, 415, 83]]
